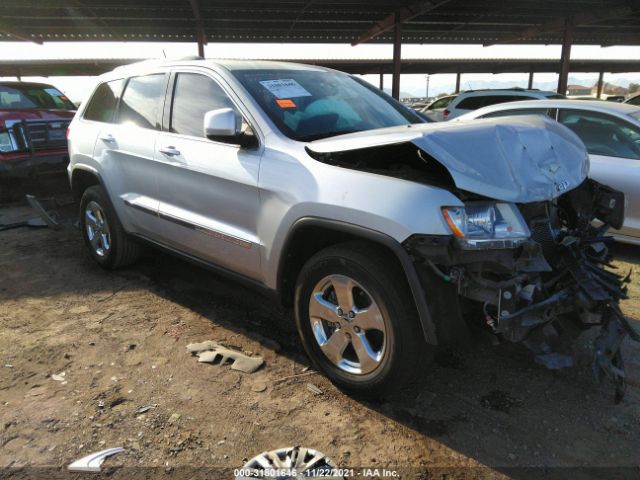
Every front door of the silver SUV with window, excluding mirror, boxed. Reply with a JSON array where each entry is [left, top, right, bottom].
[[155, 70, 262, 279]]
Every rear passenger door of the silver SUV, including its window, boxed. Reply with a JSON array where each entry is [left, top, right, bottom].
[[94, 73, 168, 239]]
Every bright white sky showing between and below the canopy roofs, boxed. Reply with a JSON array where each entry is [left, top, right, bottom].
[[0, 42, 640, 101]]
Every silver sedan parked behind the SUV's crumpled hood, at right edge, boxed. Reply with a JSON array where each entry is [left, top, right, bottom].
[[458, 100, 640, 244]]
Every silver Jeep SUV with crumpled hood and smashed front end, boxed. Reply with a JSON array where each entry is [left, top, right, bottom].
[[69, 60, 629, 395]]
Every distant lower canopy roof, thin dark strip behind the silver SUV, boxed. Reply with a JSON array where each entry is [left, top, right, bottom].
[[5, 58, 640, 77]]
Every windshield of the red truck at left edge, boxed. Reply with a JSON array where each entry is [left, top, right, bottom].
[[0, 84, 76, 110]]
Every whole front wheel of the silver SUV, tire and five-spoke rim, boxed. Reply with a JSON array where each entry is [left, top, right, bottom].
[[295, 242, 431, 398]]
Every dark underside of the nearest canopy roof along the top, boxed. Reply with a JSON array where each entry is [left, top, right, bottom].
[[0, 0, 640, 45]]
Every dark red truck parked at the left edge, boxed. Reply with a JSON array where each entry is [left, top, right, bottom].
[[0, 81, 76, 178]]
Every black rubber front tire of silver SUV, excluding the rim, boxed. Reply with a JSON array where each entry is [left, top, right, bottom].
[[294, 242, 433, 398]]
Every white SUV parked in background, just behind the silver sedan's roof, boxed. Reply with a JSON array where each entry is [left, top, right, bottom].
[[442, 88, 566, 120]]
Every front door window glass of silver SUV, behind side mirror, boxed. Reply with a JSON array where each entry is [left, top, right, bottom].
[[169, 73, 235, 137]]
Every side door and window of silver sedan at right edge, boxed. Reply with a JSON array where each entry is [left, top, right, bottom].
[[558, 108, 640, 237]]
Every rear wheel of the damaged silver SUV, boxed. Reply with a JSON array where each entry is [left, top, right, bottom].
[[80, 185, 140, 269]]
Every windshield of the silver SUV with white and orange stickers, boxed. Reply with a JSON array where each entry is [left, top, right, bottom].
[[232, 69, 423, 142]]
